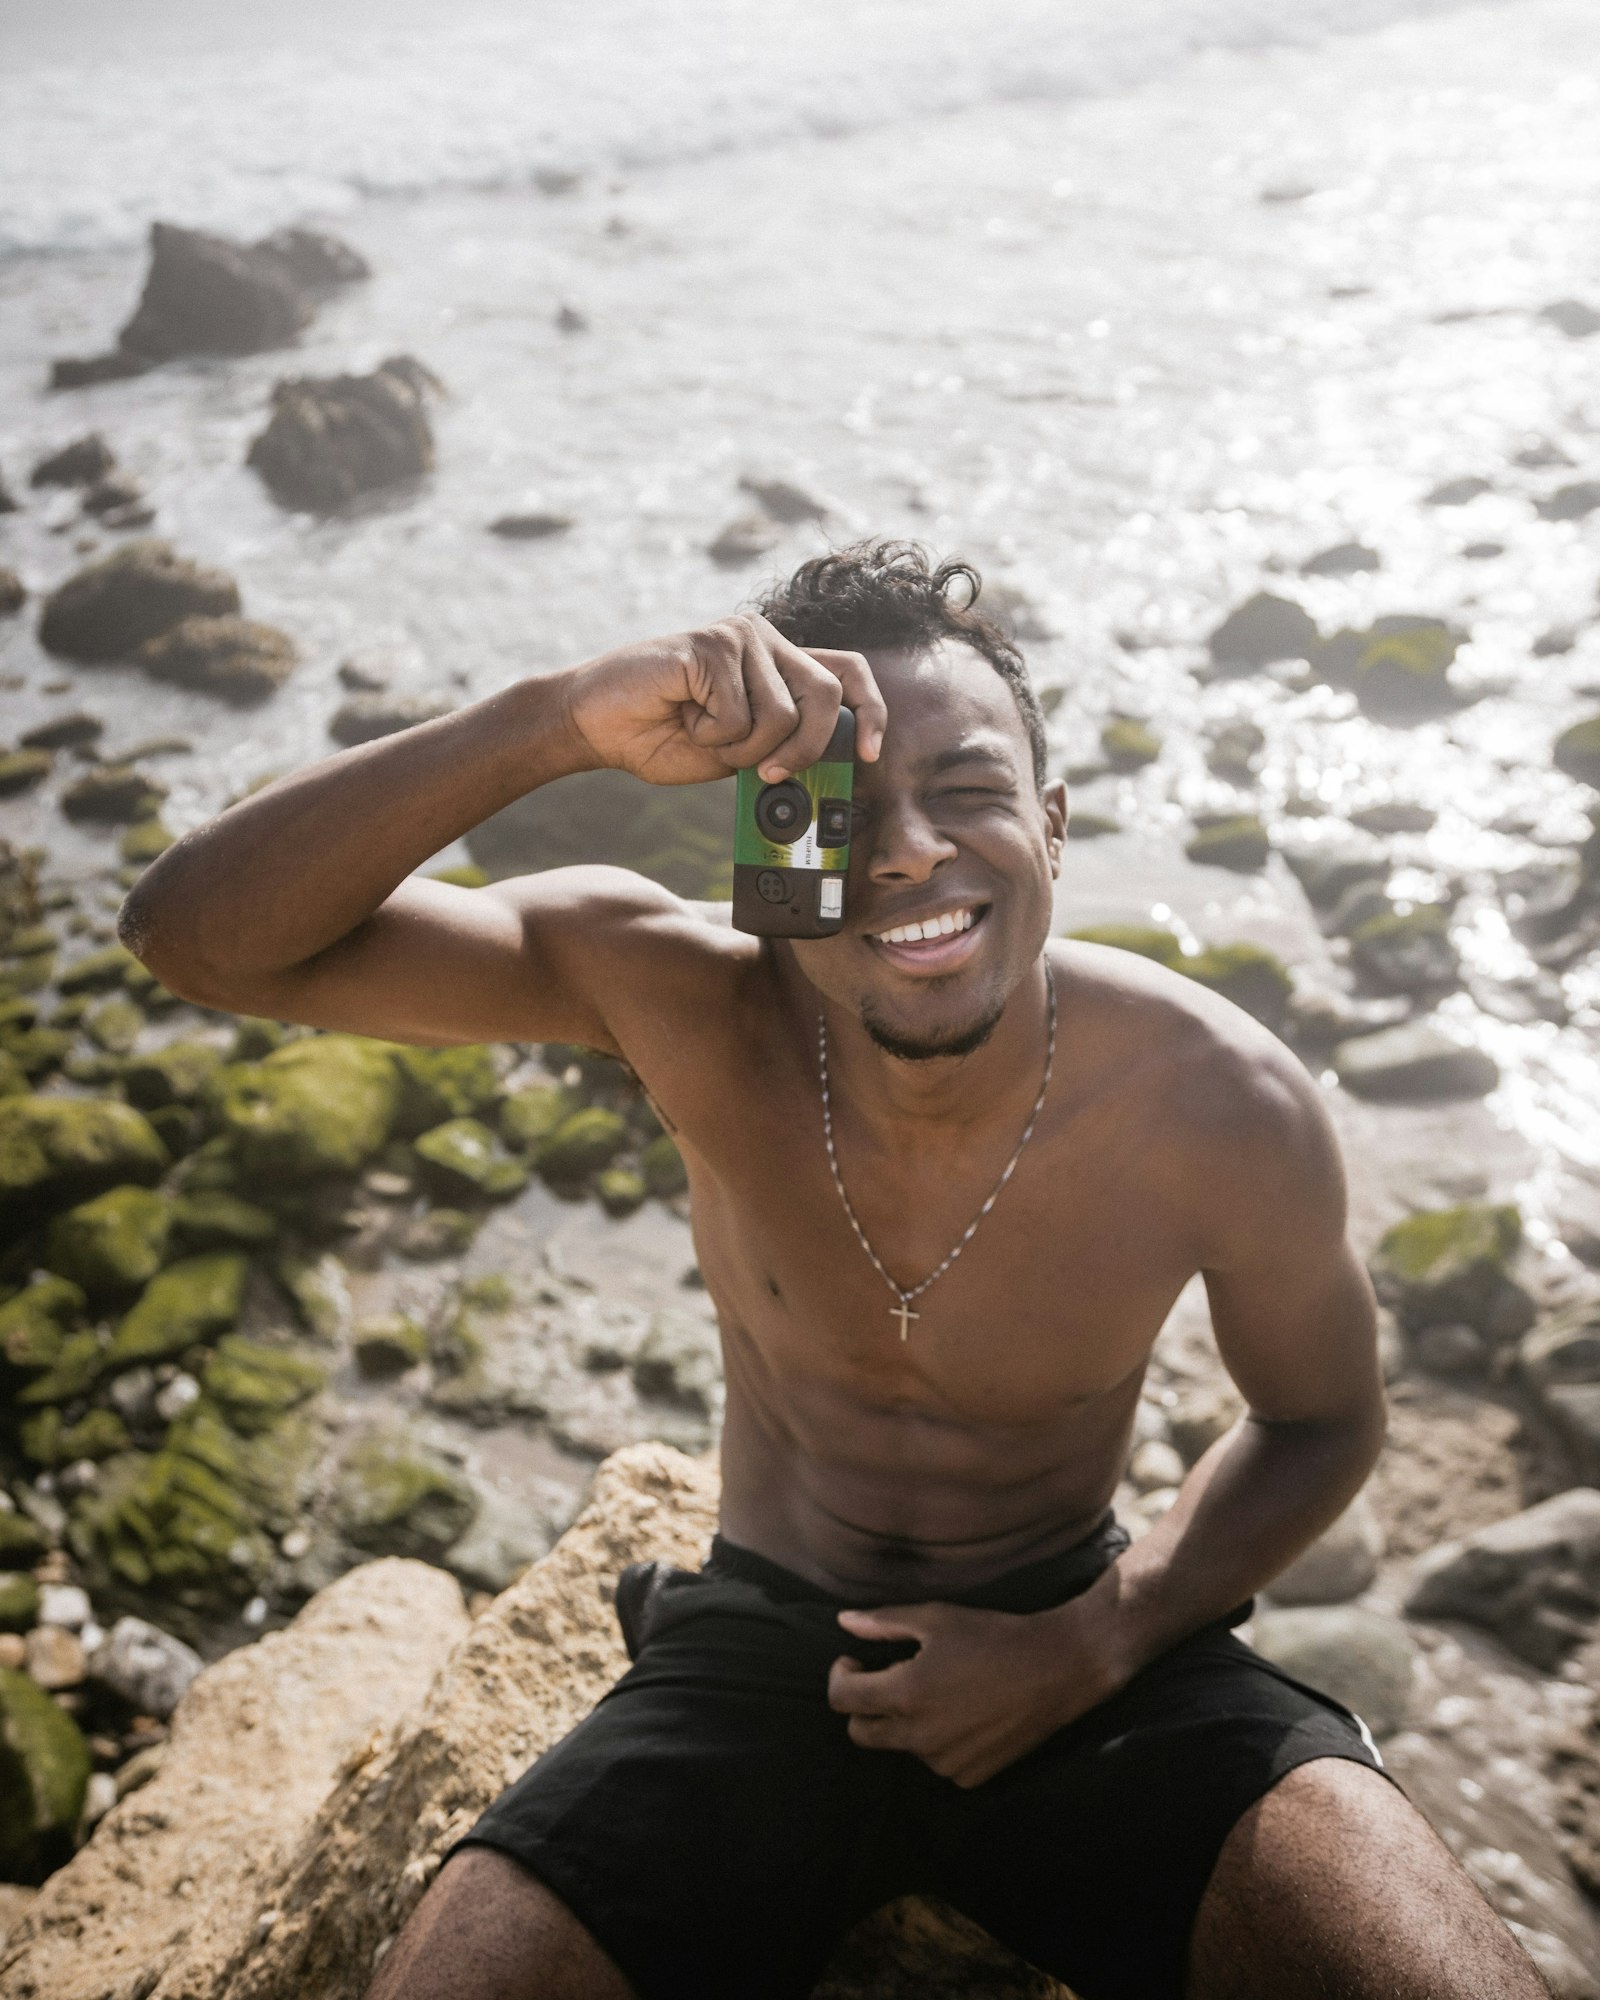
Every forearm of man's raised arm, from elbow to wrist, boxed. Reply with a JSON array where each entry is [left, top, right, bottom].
[[122, 674, 594, 1004]]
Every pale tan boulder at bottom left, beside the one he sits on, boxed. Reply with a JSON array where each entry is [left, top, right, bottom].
[[0, 1560, 468, 2000]]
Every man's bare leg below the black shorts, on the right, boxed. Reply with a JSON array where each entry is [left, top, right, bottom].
[[1186, 1758, 1550, 2000]]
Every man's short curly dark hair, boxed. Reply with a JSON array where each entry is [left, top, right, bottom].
[[758, 542, 1046, 788]]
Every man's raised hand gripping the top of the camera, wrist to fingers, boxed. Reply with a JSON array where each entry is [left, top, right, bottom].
[[568, 616, 886, 784]]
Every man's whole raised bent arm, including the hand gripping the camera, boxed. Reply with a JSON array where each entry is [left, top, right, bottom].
[[120, 618, 884, 1046]]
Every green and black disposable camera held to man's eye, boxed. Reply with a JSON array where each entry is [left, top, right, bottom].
[[734, 708, 856, 938]]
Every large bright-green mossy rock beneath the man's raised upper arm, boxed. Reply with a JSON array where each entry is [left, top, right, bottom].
[[216, 1034, 400, 1180]]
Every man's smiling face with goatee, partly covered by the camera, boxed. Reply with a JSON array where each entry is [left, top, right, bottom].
[[794, 642, 1066, 1058]]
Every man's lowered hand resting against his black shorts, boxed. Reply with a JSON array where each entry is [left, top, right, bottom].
[[828, 1600, 1128, 1788]]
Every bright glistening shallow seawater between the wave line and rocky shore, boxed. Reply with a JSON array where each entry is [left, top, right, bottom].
[[0, 0, 1600, 1224]]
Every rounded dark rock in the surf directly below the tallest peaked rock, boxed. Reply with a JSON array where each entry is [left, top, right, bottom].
[[248, 354, 438, 514]]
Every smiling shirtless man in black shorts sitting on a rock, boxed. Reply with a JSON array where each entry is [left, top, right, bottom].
[[124, 544, 1546, 2000]]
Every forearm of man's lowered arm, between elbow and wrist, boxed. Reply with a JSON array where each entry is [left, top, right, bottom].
[[1064, 1402, 1384, 1684]]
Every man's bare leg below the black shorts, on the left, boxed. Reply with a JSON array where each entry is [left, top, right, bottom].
[[366, 1848, 636, 2000]]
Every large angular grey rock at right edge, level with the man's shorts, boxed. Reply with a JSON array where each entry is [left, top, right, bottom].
[[1406, 1486, 1600, 1674]]
